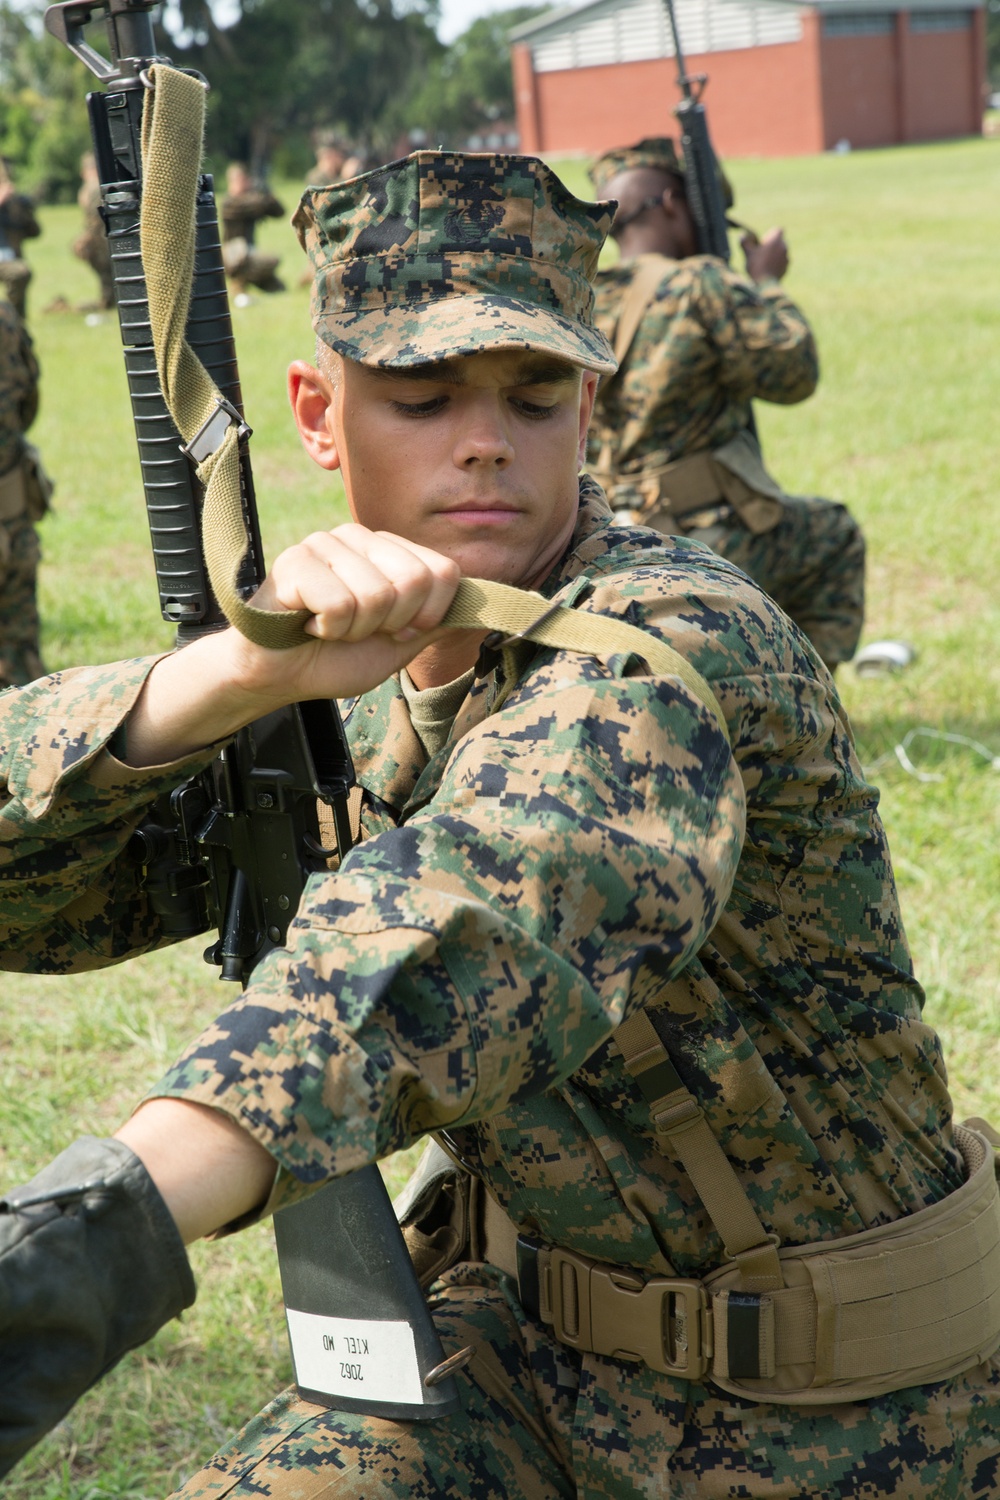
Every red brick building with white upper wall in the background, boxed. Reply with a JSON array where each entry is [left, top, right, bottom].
[[511, 0, 987, 158]]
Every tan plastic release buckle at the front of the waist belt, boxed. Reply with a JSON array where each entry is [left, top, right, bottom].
[[546, 1250, 712, 1380]]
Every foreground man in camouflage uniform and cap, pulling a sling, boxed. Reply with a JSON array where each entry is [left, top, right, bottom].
[[0, 153, 1000, 1500]]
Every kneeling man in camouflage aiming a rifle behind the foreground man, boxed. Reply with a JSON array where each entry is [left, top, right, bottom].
[[588, 138, 865, 668]]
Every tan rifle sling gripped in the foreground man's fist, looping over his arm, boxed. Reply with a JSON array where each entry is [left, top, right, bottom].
[[139, 63, 729, 740]]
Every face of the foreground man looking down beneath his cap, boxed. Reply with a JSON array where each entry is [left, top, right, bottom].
[[289, 353, 597, 588]]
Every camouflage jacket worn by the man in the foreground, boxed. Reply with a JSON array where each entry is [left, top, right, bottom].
[[0, 482, 964, 1275]]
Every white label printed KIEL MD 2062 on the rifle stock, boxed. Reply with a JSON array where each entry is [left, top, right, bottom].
[[285, 1308, 424, 1406]]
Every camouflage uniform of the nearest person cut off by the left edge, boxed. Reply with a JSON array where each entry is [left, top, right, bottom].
[[0, 297, 45, 689]]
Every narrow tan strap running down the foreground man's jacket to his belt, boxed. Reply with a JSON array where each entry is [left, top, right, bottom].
[[615, 1011, 784, 1292]]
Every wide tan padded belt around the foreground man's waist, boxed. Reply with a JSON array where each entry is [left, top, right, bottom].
[[481, 1121, 1000, 1406]]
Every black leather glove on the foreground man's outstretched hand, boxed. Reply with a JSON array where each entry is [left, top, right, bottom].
[[0, 1136, 195, 1476]]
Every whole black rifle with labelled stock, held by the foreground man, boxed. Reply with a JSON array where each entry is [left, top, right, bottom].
[[45, 0, 457, 1418]]
